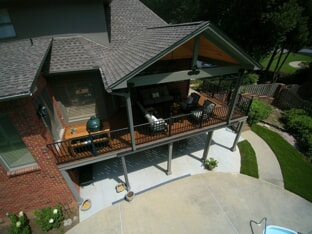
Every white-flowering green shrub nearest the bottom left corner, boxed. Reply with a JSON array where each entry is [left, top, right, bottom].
[[7, 211, 31, 234]]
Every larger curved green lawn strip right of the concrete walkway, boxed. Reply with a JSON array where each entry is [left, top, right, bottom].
[[252, 125, 312, 202]]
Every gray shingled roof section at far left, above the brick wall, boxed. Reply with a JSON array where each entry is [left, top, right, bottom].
[[0, 38, 52, 99]]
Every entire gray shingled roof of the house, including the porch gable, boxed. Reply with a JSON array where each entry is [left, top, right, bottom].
[[0, 0, 261, 100]]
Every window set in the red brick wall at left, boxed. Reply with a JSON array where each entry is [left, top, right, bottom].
[[0, 113, 37, 171]]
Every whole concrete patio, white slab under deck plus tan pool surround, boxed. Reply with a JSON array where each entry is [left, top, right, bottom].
[[68, 129, 312, 233]]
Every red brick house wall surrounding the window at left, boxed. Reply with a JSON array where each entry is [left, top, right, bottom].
[[0, 77, 75, 217]]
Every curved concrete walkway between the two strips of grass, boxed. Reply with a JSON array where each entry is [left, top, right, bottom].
[[241, 130, 284, 188]]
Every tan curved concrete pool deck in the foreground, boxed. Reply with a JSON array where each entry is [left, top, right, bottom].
[[67, 172, 312, 234]]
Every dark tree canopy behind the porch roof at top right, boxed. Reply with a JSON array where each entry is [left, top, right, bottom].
[[142, 0, 312, 63]]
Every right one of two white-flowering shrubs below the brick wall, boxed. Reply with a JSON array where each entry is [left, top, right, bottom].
[[35, 205, 64, 232]]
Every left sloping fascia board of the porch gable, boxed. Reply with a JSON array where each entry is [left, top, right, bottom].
[[107, 22, 210, 92]]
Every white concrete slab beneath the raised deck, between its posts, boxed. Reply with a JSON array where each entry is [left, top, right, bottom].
[[80, 128, 240, 221]]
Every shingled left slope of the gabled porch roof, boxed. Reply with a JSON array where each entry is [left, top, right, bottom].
[[100, 22, 209, 86]]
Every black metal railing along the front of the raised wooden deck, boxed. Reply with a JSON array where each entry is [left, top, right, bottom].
[[47, 100, 249, 164]]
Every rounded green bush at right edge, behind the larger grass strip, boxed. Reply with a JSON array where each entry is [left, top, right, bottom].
[[283, 109, 312, 157]]
